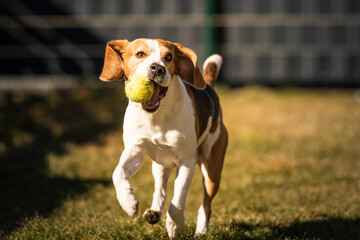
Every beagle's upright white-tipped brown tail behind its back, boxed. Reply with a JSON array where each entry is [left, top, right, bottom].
[[203, 54, 222, 87]]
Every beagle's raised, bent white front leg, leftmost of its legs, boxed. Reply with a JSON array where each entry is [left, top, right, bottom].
[[112, 149, 144, 218]]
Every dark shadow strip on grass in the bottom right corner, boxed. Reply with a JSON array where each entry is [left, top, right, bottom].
[[230, 218, 360, 240]]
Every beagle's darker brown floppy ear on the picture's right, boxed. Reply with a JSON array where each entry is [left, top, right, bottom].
[[174, 43, 206, 89]]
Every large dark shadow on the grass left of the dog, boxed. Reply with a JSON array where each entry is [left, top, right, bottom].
[[0, 88, 126, 235]]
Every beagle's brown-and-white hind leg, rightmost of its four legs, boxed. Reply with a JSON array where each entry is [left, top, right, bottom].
[[195, 124, 228, 234]]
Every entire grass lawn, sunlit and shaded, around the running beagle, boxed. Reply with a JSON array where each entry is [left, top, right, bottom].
[[0, 87, 360, 239]]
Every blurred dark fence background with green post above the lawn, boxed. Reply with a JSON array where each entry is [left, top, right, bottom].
[[0, 0, 360, 89]]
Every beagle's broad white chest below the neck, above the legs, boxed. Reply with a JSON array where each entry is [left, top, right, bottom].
[[124, 104, 197, 167]]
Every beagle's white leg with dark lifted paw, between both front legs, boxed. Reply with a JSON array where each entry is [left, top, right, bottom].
[[143, 161, 172, 224]]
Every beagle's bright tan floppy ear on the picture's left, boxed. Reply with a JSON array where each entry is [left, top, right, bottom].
[[100, 40, 129, 82]]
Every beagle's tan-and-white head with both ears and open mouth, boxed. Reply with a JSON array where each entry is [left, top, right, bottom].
[[100, 39, 206, 112]]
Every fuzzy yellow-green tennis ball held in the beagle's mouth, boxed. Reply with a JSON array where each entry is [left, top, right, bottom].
[[125, 74, 154, 103]]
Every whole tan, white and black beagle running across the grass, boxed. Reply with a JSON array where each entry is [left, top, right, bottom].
[[100, 39, 228, 239]]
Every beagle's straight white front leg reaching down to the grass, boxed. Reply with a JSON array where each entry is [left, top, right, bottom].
[[166, 159, 195, 239]]
